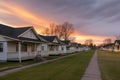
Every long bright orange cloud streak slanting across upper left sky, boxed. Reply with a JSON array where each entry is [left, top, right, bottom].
[[0, 2, 49, 28]]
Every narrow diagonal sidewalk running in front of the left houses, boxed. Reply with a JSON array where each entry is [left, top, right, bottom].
[[0, 54, 75, 77]]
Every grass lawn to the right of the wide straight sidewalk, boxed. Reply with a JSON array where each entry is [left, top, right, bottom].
[[98, 51, 120, 80]]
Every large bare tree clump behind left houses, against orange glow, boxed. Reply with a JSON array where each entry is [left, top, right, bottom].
[[44, 22, 74, 40]]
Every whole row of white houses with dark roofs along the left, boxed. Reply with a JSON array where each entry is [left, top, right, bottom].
[[0, 24, 87, 62]]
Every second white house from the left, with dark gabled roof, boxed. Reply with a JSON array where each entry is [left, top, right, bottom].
[[39, 35, 66, 55]]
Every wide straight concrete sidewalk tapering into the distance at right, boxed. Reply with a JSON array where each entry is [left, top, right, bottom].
[[81, 51, 102, 80]]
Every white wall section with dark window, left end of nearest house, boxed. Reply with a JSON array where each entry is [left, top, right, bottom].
[[0, 42, 7, 61]]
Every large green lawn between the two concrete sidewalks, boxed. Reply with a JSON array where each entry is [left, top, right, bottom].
[[0, 51, 94, 80]]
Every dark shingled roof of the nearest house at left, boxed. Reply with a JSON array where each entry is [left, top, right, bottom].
[[0, 24, 44, 42]]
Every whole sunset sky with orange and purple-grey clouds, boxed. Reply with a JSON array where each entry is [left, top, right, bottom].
[[0, 0, 120, 44]]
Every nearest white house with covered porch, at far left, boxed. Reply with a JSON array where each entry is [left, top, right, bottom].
[[0, 24, 44, 61]]
